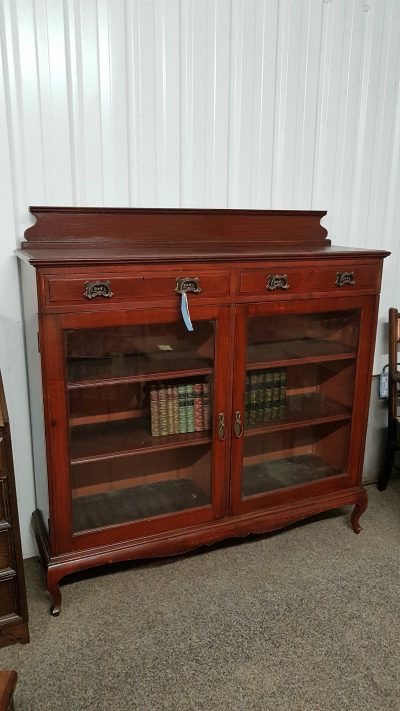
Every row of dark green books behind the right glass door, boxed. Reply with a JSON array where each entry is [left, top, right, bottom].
[[245, 368, 286, 426]]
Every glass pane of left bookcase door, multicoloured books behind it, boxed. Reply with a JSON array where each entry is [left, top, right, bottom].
[[64, 320, 216, 533]]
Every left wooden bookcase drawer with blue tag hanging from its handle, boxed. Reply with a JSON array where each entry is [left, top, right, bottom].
[[45, 271, 230, 305]]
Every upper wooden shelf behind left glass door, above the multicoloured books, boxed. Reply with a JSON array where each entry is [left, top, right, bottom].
[[68, 352, 213, 390]]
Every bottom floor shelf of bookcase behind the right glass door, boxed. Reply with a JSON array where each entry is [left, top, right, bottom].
[[242, 454, 343, 497]]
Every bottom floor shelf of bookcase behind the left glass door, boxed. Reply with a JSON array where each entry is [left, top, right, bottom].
[[72, 479, 210, 532]]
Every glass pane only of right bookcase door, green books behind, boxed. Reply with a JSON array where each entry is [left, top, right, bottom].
[[242, 310, 360, 497]]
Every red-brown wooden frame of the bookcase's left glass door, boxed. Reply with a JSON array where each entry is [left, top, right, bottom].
[[39, 304, 232, 556]]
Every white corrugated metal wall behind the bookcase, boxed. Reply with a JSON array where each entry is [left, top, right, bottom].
[[0, 0, 400, 555]]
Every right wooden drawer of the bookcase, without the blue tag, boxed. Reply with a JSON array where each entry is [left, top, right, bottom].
[[239, 264, 380, 298]]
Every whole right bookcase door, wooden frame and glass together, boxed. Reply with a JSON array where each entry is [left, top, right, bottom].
[[232, 300, 374, 511]]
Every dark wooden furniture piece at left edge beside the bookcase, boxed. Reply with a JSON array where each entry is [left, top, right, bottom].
[[0, 375, 29, 647]]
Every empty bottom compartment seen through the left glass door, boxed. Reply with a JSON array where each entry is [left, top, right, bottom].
[[71, 444, 211, 532]]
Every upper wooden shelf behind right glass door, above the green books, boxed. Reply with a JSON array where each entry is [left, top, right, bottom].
[[246, 338, 356, 370]]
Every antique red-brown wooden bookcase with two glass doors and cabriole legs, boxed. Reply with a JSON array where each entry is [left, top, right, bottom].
[[18, 207, 387, 614]]
